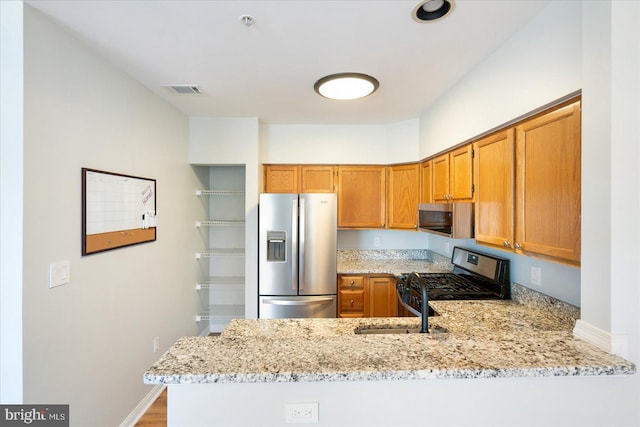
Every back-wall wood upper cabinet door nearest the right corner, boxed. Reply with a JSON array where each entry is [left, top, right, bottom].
[[387, 163, 420, 230]]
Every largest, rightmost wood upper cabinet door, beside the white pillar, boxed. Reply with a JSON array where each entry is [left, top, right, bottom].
[[515, 101, 581, 262]]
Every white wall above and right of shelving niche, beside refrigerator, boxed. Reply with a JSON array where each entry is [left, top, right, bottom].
[[189, 117, 262, 319]]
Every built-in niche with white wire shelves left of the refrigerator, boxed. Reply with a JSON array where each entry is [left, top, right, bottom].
[[192, 166, 245, 332]]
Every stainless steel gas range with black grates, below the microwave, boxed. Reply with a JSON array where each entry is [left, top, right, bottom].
[[396, 246, 511, 316]]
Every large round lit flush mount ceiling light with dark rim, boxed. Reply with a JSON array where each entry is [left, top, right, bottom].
[[313, 73, 380, 100]]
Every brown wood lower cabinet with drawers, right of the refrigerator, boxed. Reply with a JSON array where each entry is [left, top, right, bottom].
[[338, 274, 398, 317]]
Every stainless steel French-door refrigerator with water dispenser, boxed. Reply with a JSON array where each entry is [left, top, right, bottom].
[[258, 193, 338, 319]]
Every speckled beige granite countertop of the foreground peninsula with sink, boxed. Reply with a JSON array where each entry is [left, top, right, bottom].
[[144, 301, 636, 384]]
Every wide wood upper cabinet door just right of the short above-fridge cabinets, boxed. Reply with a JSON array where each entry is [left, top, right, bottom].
[[338, 166, 386, 228]]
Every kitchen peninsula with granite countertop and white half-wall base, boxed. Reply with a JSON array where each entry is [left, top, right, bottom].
[[144, 251, 636, 426]]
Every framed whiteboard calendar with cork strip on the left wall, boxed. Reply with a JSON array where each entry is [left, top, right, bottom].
[[82, 168, 157, 256]]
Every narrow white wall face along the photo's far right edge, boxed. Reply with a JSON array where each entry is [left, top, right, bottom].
[[608, 1, 640, 364]]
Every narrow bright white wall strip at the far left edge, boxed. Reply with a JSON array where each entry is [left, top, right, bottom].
[[0, 2, 23, 403]]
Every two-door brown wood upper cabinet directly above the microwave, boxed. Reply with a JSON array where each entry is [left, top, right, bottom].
[[432, 144, 474, 202]]
